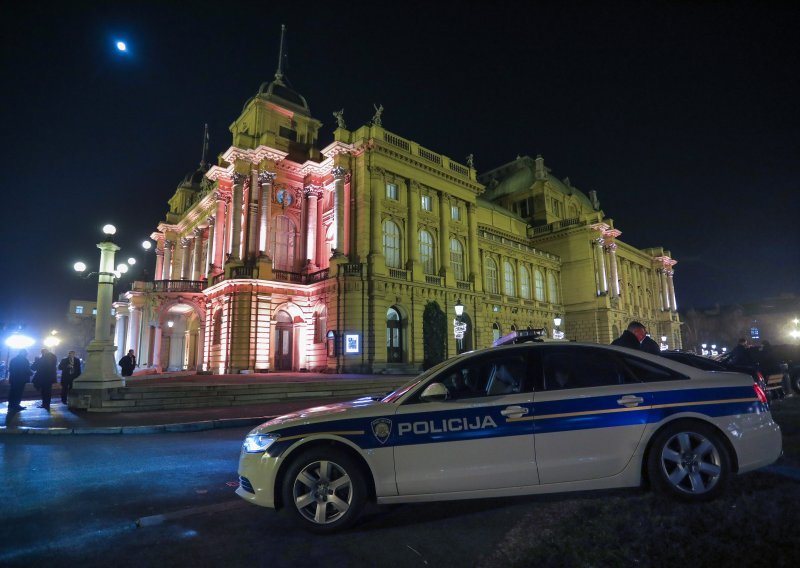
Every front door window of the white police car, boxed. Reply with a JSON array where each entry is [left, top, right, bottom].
[[439, 352, 530, 400]]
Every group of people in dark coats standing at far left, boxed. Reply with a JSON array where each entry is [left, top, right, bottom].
[[8, 347, 81, 413]]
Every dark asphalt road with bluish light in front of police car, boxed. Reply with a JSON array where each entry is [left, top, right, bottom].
[[0, 428, 548, 568]]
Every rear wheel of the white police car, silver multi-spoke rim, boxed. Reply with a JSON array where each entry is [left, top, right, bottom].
[[647, 421, 731, 501]]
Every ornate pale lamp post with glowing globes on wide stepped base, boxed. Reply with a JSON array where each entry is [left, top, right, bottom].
[[69, 225, 128, 394]]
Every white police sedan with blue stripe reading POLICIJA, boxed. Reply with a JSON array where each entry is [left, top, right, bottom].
[[236, 343, 781, 532]]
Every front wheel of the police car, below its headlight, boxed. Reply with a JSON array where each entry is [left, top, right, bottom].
[[282, 448, 367, 533]]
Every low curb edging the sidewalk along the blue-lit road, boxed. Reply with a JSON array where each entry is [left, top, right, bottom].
[[0, 415, 276, 436]]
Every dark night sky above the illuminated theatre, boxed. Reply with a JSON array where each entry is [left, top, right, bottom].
[[0, 1, 800, 338]]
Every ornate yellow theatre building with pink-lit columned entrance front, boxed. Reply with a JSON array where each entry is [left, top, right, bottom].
[[114, 64, 681, 373]]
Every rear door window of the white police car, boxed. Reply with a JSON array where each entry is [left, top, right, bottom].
[[542, 349, 624, 390]]
